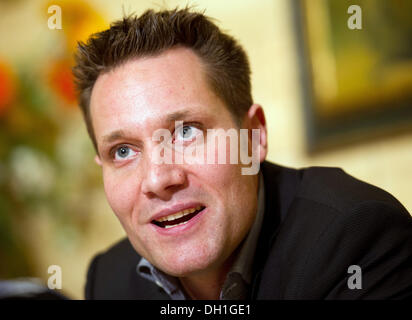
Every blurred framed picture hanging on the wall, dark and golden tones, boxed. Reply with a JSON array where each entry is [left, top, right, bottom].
[[292, 0, 412, 153]]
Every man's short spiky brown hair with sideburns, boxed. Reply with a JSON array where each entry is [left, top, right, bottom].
[[73, 8, 253, 152]]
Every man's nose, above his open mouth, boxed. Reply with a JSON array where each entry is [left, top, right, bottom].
[[142, 164, 186, 200]]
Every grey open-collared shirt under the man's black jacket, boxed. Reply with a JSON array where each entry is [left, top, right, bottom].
[[136, 173, 265, 300]]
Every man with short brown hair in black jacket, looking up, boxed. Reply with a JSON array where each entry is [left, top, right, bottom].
[[74, 9, 412, 299]]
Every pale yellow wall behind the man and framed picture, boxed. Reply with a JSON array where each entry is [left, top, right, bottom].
[[0, 0, 412, 298]]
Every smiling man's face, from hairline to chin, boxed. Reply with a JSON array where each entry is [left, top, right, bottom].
[[91, 48, 258, 276]]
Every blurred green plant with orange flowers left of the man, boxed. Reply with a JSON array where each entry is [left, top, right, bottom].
[[0, 0, 108, 278]]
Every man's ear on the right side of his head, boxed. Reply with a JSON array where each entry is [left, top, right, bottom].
[[244, 104, 268, 162]]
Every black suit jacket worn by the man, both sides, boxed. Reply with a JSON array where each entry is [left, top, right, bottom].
[[85, 162, 412, 299]]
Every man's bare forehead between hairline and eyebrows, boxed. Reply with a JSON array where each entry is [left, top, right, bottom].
[[90, 48, 214, 114]]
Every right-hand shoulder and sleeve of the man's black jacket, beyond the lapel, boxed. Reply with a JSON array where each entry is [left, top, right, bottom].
[[257, 162, 412, 299]]
